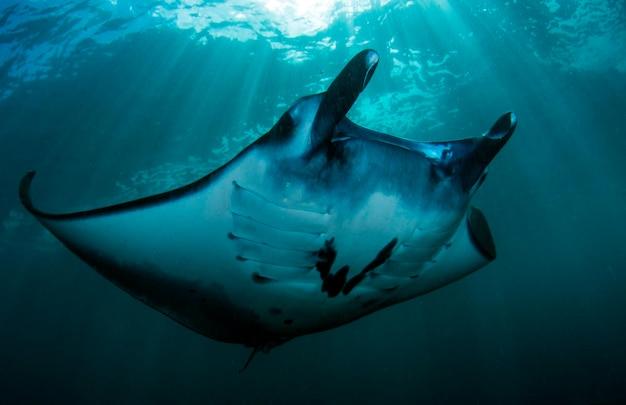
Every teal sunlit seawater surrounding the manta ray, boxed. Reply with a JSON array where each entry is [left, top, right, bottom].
[[0, 0, 626, 404]]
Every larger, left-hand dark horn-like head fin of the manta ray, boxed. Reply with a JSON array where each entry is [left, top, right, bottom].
[[311, 49, 379, 145]]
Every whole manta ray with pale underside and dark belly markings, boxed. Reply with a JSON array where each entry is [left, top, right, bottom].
[[19, 50, 516, 366]]
